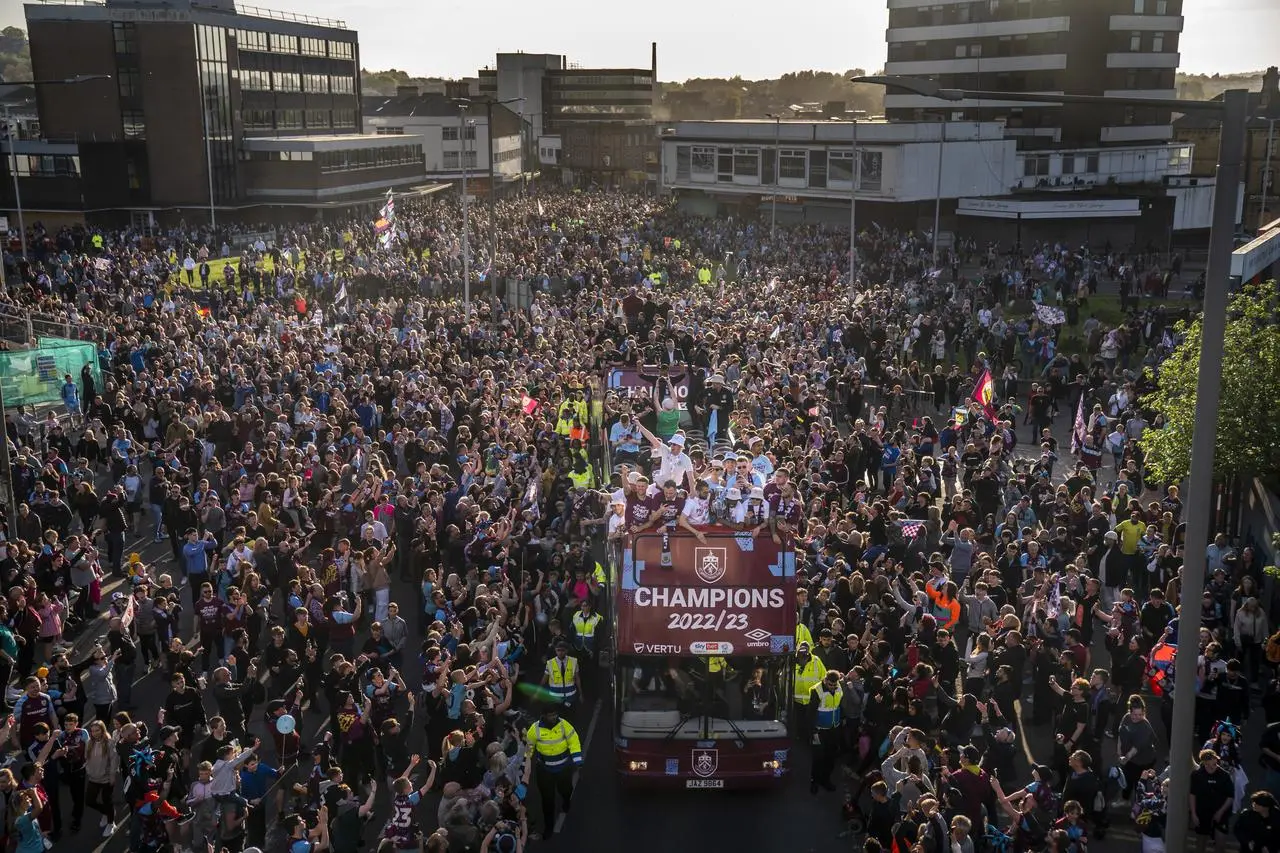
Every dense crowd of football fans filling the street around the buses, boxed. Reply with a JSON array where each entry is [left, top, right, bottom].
[[0, 188, 1280, 853]]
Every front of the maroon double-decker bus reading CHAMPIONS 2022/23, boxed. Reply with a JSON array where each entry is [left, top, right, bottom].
[[612, 528, 796, 789]]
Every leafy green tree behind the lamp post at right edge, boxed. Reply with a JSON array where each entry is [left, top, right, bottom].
[[1142, 282, 1280, 483]]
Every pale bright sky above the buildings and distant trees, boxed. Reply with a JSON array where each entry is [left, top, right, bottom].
[[0, 0, 1280, 81]]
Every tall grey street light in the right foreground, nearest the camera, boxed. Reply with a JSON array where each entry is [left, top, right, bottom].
[[852, 77, 1249, 853]]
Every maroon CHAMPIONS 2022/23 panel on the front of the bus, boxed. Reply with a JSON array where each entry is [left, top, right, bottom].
[[617, 528, 796, 656]]
